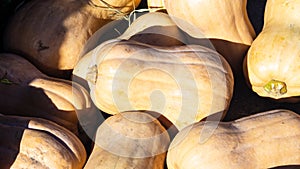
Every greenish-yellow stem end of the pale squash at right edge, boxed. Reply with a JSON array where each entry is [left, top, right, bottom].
[[264, 79, 287, 96]]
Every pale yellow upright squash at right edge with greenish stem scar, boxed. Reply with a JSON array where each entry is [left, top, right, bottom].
[[244, 0, 300, 101]]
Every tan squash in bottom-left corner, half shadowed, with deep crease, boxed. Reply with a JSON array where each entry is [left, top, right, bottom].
[[0, 113, 87, 169]]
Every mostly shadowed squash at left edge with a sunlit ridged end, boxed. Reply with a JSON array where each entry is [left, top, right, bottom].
[[0, 53, 100, 145]]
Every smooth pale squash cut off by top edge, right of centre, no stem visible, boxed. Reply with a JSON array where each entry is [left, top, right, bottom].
[[164, 0, 255, 45]]
